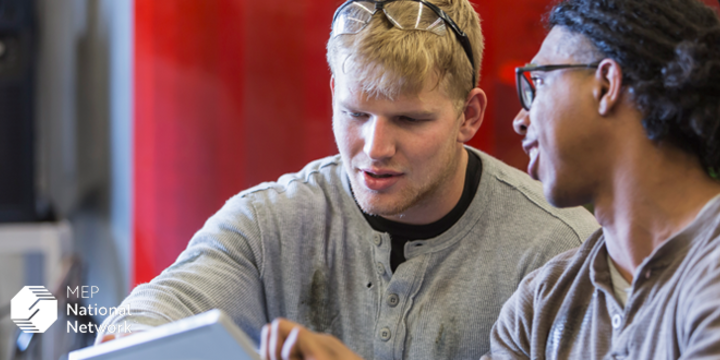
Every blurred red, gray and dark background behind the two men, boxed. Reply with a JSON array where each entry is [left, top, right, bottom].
[[0, 0, 718, 360]]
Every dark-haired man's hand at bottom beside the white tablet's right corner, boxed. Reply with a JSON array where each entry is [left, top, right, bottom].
[[260, 319, 362, 360]]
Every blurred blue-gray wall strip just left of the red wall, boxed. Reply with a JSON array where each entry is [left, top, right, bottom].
[[36, 0, 133, 318]]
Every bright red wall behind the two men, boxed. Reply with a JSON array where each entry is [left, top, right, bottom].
[[134, 0, 714, 284]]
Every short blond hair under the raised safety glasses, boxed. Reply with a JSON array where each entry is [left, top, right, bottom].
[[327, 0, 484, 106]]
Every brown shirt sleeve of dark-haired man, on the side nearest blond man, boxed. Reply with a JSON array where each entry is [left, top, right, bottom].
[[482, 270, 540, 360]]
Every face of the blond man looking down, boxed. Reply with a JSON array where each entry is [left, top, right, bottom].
[[333, 69, 464, 223]]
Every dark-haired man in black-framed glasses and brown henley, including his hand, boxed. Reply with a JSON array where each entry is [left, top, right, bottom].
[[263, 0, 720, 359]]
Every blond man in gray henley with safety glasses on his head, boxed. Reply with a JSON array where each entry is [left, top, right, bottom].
[[98, 0, 597, 359]]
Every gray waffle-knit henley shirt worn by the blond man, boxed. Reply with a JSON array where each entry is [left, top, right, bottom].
[[99, 149, 598, 360]]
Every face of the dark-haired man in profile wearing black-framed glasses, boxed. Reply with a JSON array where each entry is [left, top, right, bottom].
[[514, 27, 607, 207]]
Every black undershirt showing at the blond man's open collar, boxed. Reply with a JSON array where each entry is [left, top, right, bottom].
[[363, 150, 482, 272]]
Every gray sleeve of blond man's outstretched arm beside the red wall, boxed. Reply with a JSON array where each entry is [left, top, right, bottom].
[[96, 195, 268, 343]]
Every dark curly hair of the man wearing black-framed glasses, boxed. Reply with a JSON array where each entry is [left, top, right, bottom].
[[547, 0, 720, 178]]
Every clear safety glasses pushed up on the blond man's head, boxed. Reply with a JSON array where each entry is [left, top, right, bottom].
[[330, 0, 477, 88]]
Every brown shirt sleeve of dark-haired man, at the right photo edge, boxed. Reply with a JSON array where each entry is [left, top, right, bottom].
[[681, 249, 720, 360]]
